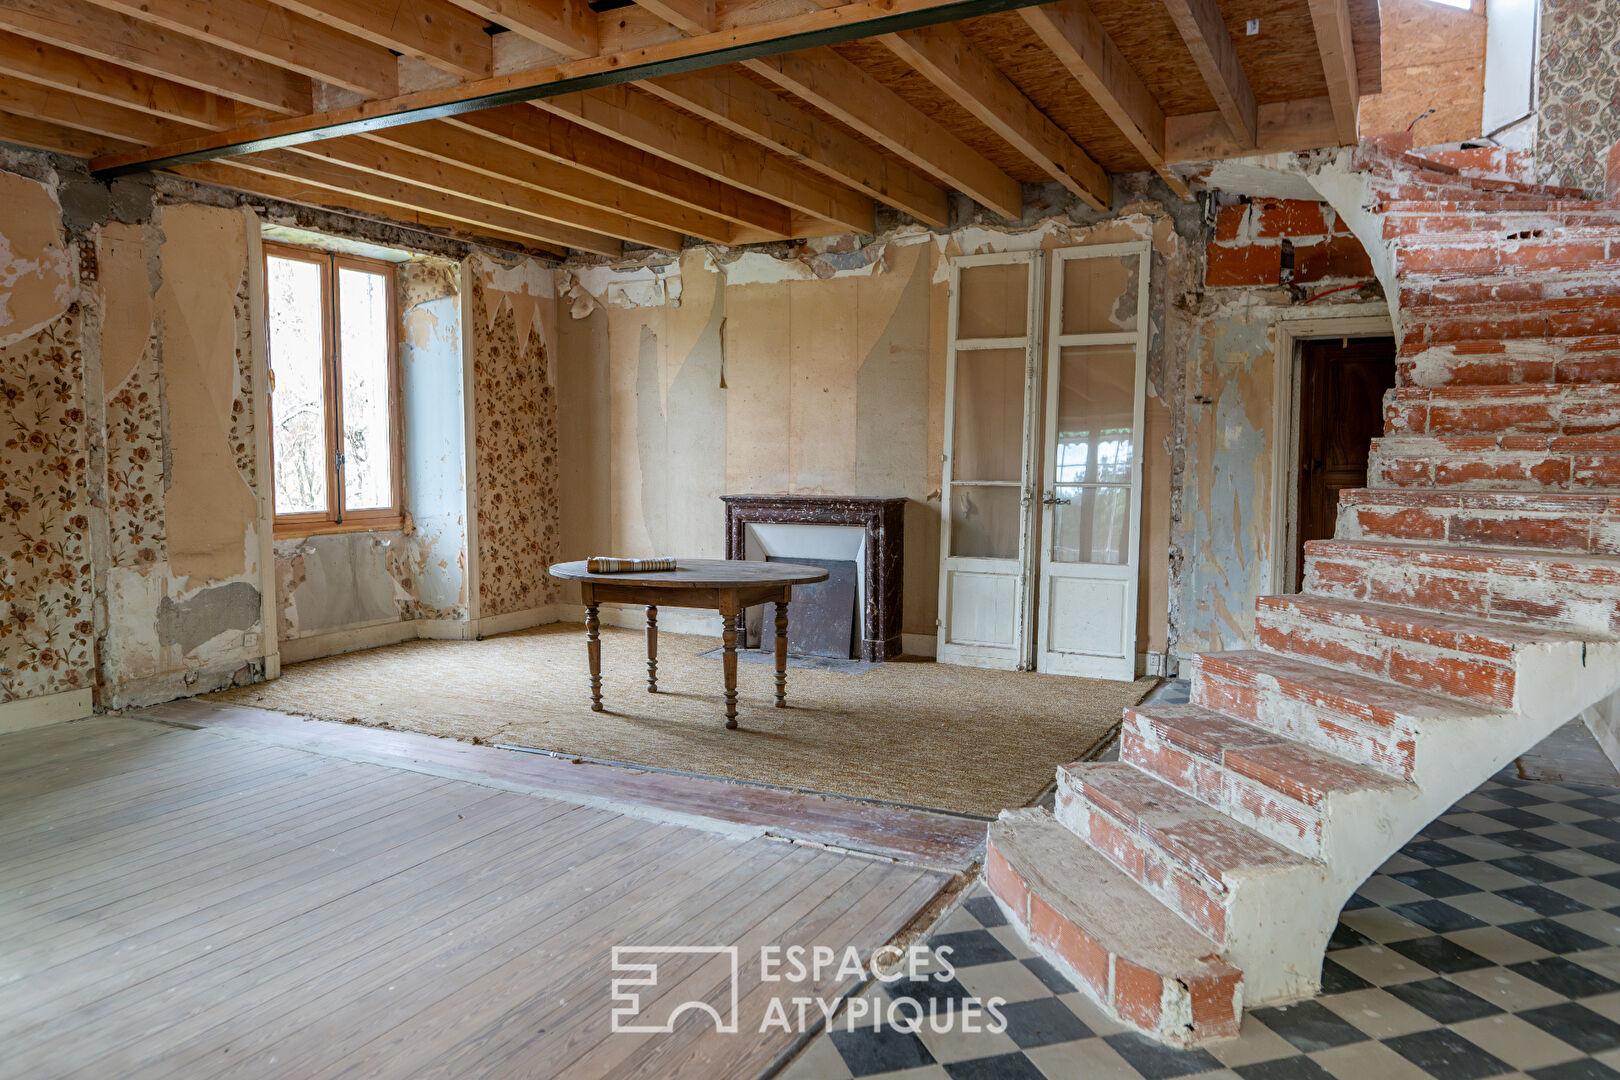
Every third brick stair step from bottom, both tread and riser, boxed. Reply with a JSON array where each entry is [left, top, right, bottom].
[[1119, 704, 1398, 858]]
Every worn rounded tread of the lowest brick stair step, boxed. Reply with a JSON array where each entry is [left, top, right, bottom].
[[990, 806, 1230, 976]]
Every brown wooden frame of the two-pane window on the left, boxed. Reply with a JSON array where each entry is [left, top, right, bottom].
[[264, 241, 405, 536]]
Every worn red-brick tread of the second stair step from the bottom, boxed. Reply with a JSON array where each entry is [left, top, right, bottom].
[[1058, 761, 1311, 887]]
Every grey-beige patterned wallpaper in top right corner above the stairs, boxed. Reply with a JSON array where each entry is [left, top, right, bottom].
[[1536, 0, 1620, 194]]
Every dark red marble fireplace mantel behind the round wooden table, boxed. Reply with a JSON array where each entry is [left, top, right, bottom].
[[721, 495, 906, 661]]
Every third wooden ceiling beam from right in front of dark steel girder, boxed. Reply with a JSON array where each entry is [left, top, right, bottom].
[[262, 0, 494, 79]]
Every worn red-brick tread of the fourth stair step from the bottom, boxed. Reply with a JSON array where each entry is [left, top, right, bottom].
[[1196, 649, 1511, 732]]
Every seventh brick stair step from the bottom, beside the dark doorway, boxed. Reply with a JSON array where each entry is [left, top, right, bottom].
[[1338, 487, 1620, 555]]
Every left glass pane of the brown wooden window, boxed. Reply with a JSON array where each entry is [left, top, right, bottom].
[[266, 256, 327, 513]]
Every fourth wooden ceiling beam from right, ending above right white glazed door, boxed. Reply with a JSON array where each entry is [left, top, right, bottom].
[[878, 26, 1113, 210]]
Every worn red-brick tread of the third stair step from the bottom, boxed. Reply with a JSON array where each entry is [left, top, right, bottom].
[[1126, 704, 1403, 806]]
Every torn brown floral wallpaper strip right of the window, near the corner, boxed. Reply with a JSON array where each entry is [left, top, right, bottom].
[[467, 272, 559, 617]]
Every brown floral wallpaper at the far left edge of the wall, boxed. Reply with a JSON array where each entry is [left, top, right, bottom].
[[0, 303, 96, 703]]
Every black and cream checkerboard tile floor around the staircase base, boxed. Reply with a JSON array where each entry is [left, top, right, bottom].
[[781, 772, 1620, 1080]]
